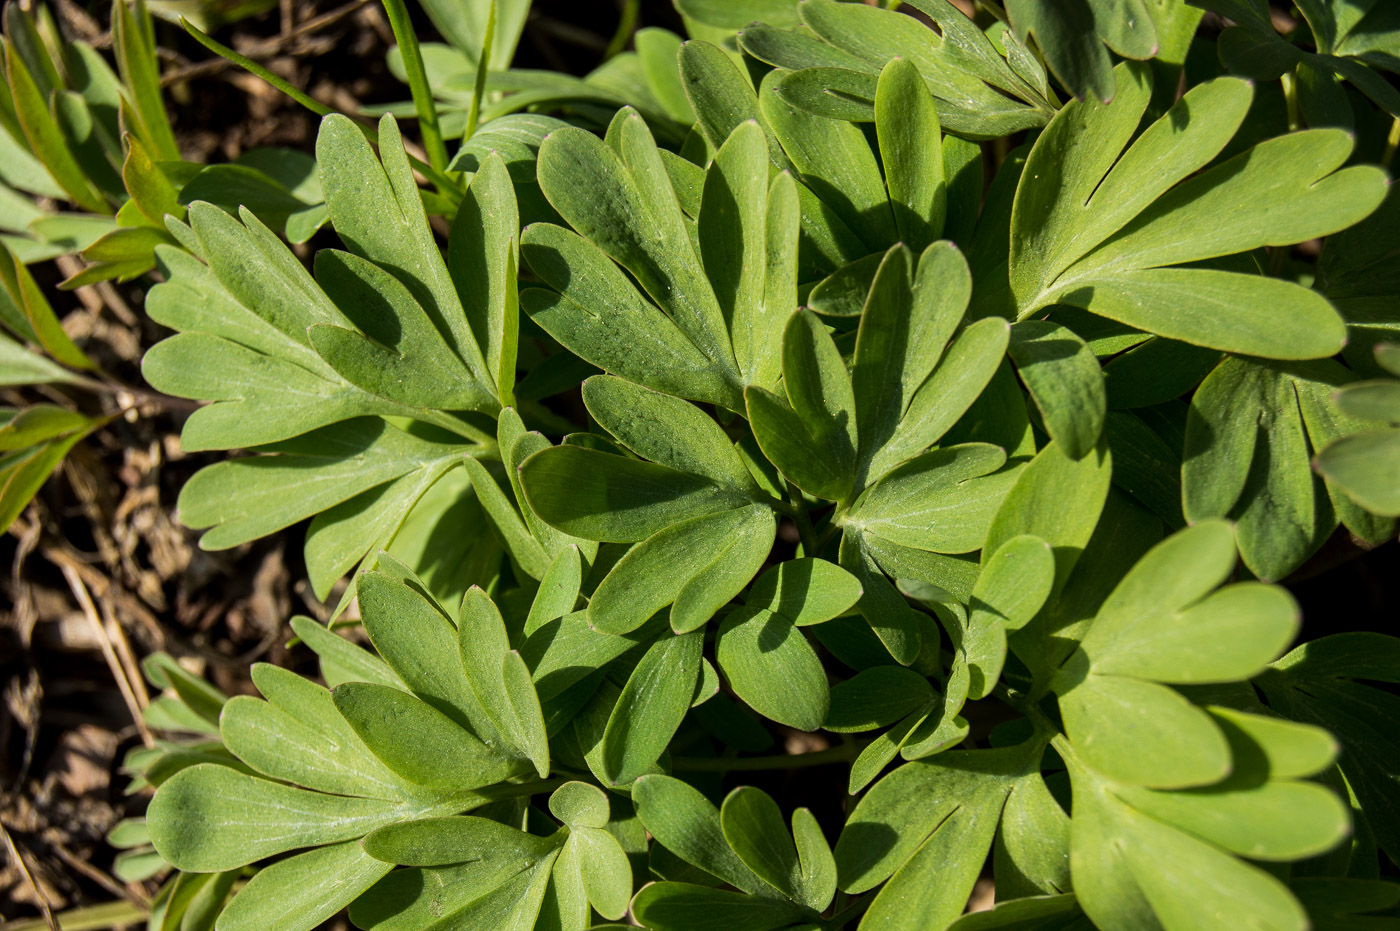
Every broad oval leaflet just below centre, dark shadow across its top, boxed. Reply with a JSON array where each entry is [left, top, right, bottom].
[[715, 608, 830, 731]]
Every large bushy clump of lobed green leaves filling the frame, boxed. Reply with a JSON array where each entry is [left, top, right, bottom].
[[8, 4, 1396, 930]]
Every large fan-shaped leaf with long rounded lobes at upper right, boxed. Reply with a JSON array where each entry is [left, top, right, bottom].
[[1011, 62, 1383, 358]]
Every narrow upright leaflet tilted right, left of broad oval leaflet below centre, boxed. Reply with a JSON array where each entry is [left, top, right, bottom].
[[602, 631, 704, 785]]
